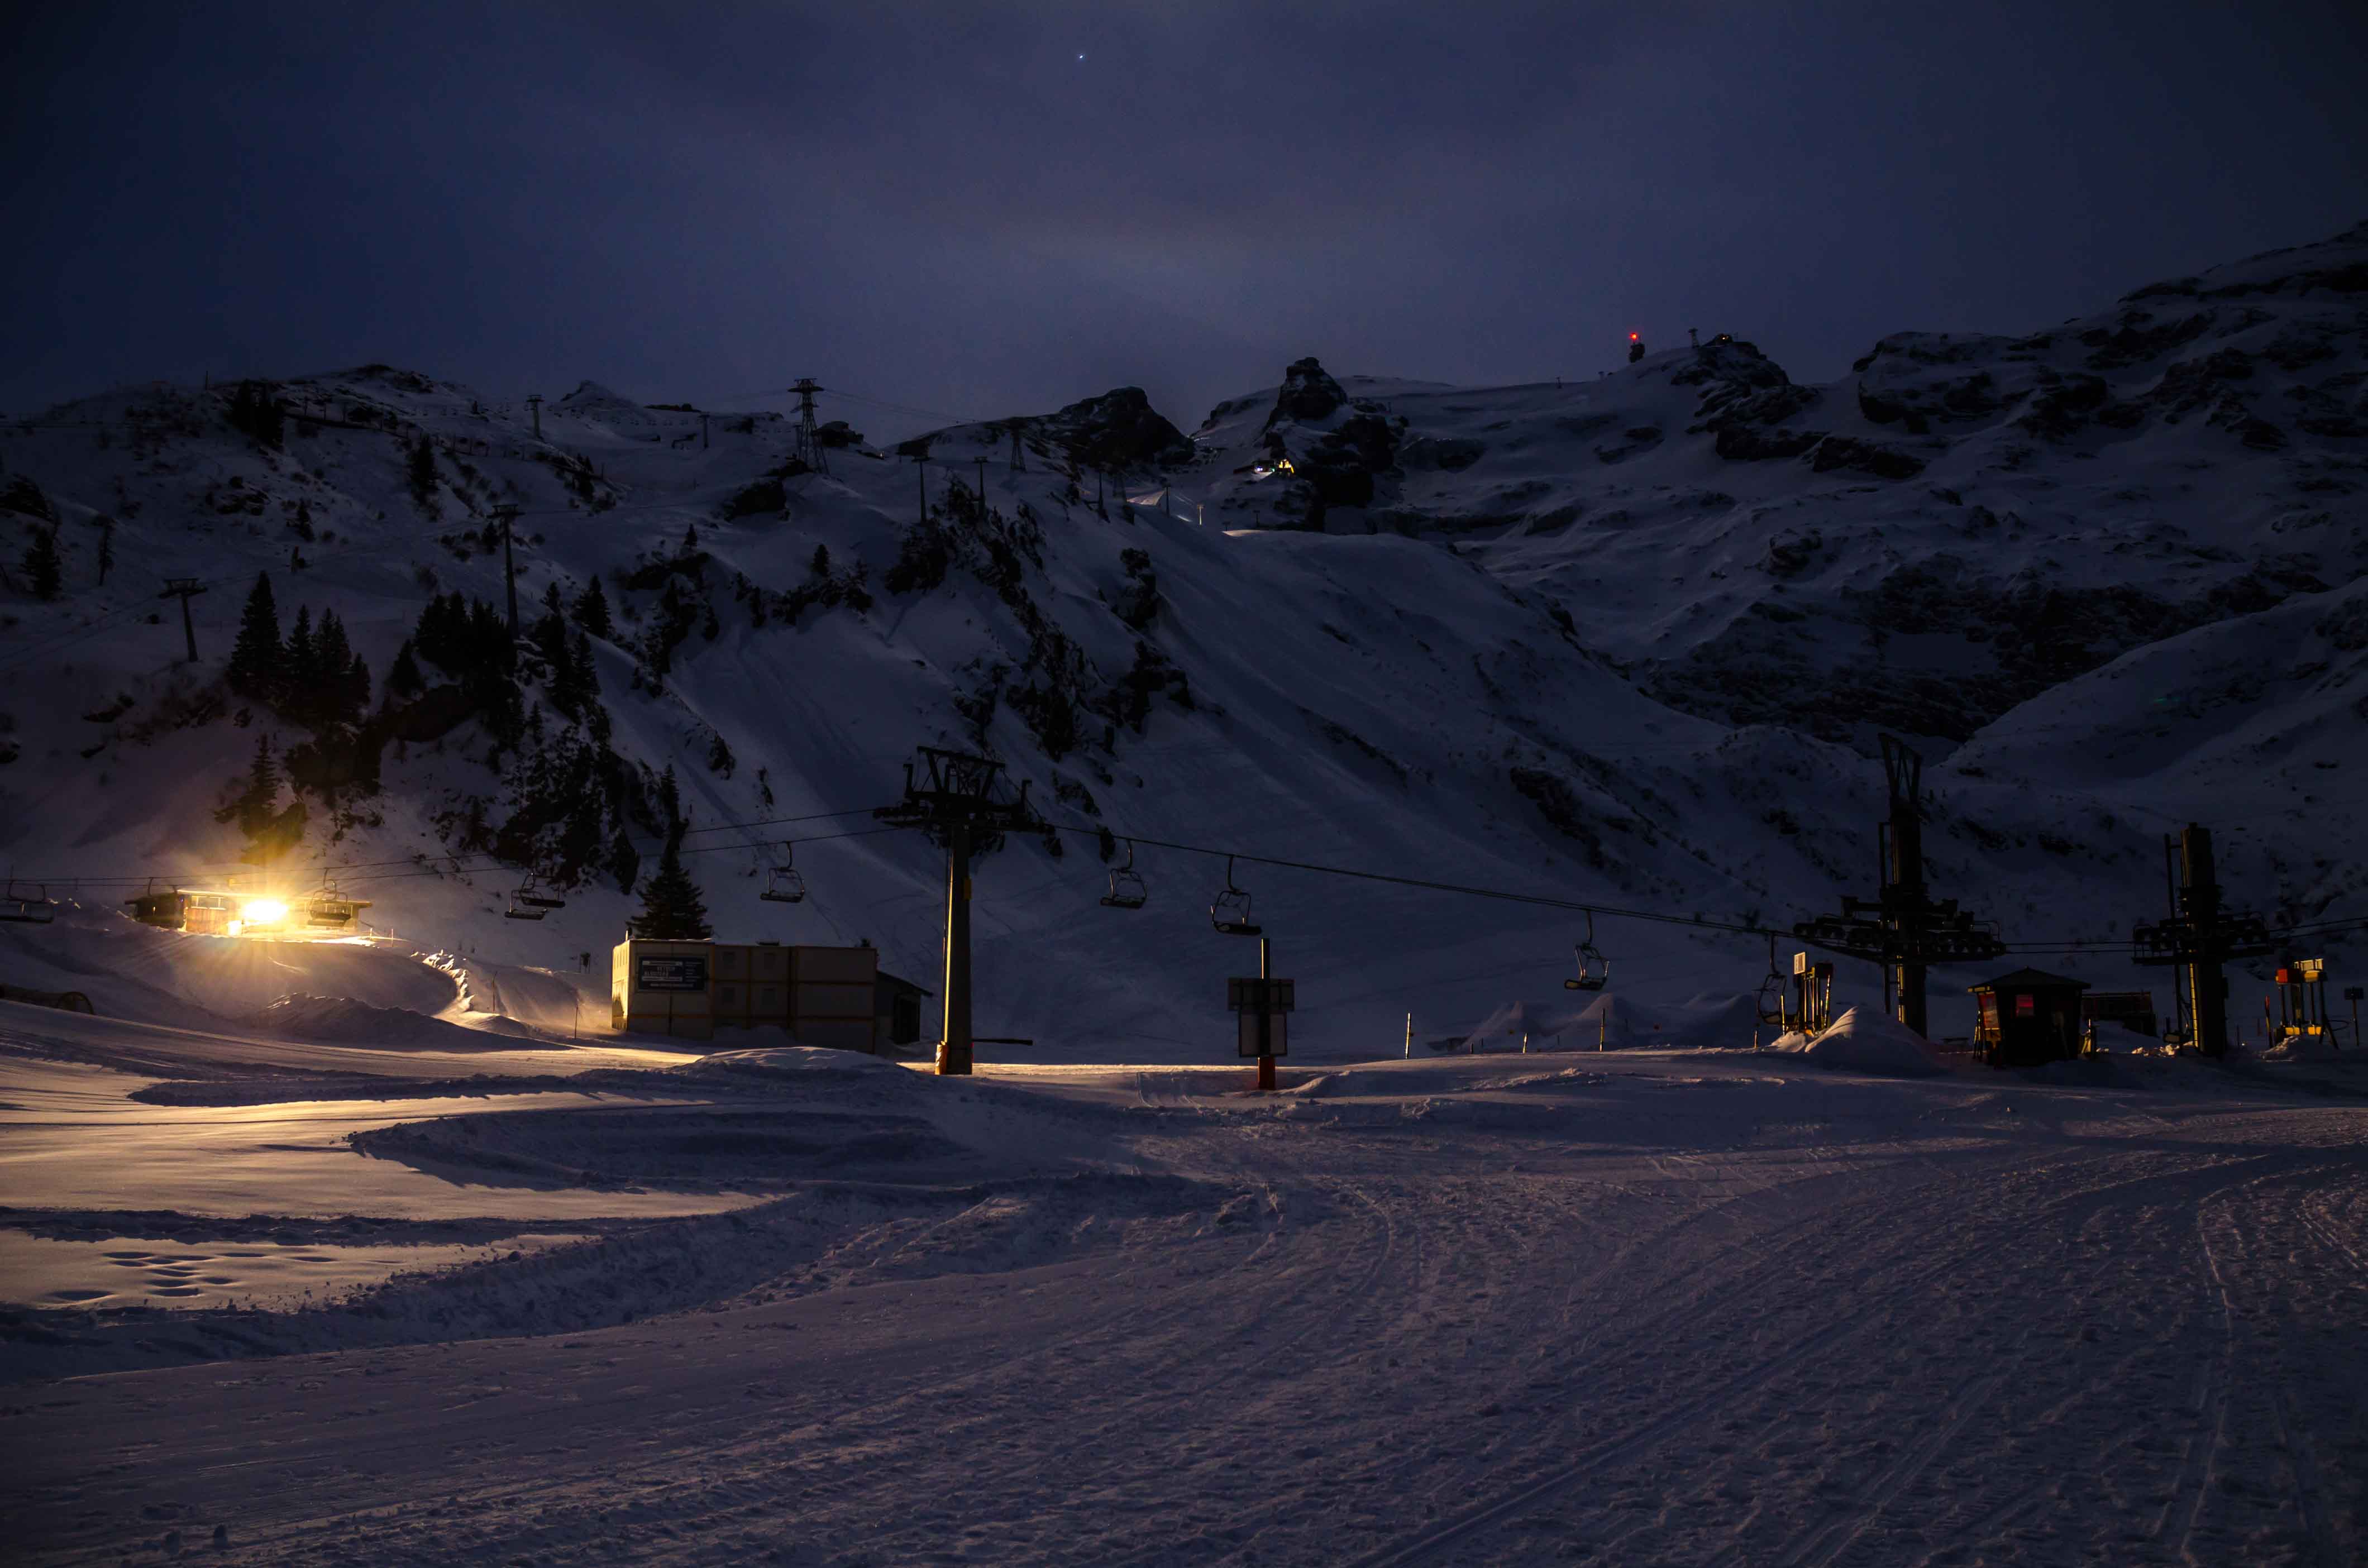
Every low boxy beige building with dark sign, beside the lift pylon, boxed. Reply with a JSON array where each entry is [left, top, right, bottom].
[[609, 938, 930, 1051]]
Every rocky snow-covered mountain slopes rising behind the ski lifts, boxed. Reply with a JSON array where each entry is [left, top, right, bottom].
[[0, 225, 2368, 1057]]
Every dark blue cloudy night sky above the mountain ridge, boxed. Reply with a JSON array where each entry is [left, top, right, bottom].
[[0, 0, 2368, 433]]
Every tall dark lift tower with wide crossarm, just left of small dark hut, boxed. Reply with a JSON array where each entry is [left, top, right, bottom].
[[1793, 734, 2006, 1035]]
